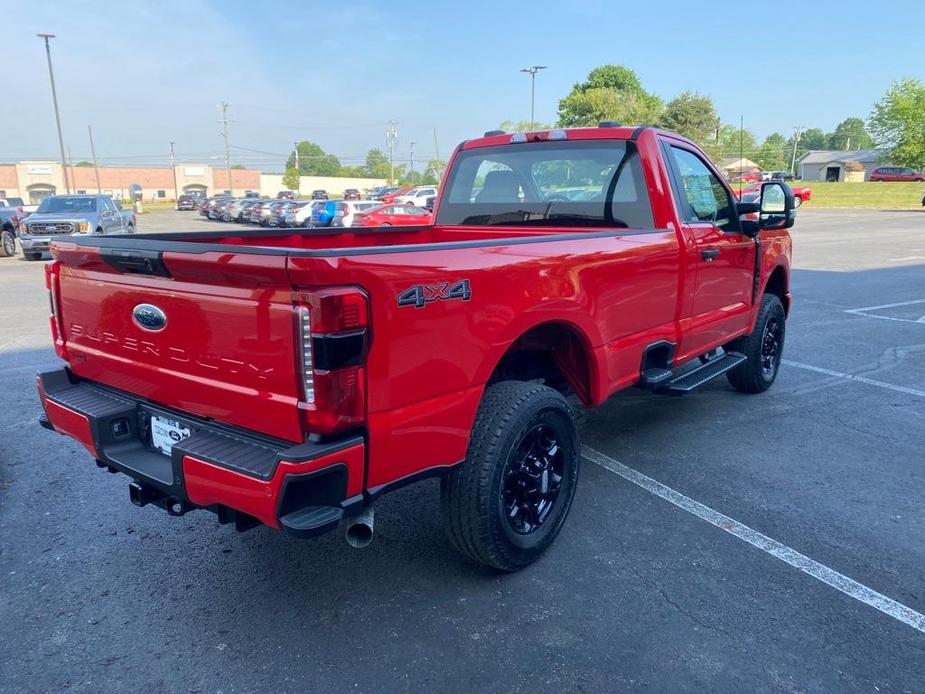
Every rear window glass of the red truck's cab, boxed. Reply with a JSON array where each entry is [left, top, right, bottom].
[[437, 140, 653, 228]]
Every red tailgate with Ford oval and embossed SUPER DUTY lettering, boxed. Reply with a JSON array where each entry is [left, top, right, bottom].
[[54, 243, 302, 441]]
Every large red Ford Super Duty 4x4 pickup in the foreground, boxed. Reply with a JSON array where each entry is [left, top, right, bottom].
[[38, 124, 794, 570]]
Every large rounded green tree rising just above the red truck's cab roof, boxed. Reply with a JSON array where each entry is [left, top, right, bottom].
[[559, 65, 664, 128]]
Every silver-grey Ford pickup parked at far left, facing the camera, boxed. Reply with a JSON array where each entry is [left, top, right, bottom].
[[19, 195, 138, 260]]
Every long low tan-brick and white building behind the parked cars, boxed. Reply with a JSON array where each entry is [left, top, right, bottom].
[[0, 161, 385, 204]]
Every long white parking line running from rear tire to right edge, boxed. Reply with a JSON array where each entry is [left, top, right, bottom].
[[581, 446, 925, 634]]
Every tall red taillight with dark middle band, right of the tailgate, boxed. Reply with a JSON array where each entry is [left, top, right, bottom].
[[294, 287, 369, 434]]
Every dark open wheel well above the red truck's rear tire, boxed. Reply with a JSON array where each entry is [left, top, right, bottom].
[[488, 323, 591, 405]]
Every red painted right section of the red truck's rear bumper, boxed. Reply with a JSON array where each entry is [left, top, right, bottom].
[[183, 444, 366, 528]]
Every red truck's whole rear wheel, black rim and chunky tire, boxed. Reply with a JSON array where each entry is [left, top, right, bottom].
[[440, 381, 580, 571]]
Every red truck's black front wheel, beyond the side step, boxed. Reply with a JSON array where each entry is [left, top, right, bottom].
[[725, 294, 786, 393]]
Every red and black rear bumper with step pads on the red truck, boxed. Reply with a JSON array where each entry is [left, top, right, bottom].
[[37, 369, 366, 537]]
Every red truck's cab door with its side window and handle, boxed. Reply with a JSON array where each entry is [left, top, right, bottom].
[[664, 142, 755, 356]]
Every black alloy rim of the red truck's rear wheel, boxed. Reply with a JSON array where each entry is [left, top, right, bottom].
[[501, 424, 565, 535]]
